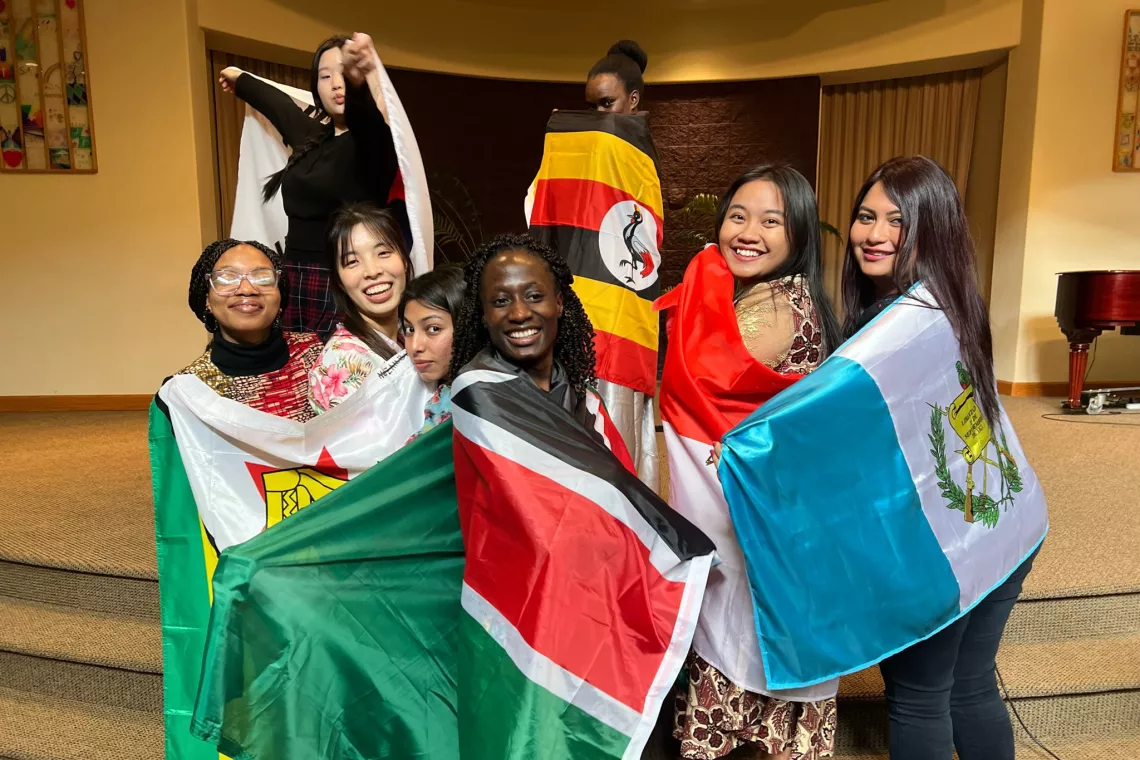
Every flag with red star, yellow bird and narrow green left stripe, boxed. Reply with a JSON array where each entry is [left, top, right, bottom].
[[149, 353, 429, 760]]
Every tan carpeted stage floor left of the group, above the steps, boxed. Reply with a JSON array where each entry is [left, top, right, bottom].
[[0, 411, 157, 578]]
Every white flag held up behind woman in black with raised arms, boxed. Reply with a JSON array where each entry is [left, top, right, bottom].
[[229, 51, 435, 272]]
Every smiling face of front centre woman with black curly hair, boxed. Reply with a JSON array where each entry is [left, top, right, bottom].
[[479, 250, 562, 390]]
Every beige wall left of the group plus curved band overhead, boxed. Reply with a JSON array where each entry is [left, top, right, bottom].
[[0, 0, 1026, 395]]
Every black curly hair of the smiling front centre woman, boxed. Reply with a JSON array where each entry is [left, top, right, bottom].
[[448, 235, 595, 393]]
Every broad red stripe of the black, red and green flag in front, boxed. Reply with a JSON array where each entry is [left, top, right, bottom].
[[454, 430, 685, 712]]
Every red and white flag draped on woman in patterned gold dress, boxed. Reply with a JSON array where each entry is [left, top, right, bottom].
[[657, 245, 837, 701]]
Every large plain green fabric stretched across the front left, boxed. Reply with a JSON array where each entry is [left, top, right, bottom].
[[193, 422, 463, 760]]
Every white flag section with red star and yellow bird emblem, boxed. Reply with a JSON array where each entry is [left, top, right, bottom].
[[158, 351, 431, 553]]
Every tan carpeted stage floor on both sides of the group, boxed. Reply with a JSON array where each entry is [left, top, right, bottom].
[[0, 398, 1140, 598]]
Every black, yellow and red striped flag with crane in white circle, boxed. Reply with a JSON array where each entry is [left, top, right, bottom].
[[526, 111, 663, 395]]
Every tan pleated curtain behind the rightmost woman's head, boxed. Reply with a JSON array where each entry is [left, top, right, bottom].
[[817, 68, 982, 305]]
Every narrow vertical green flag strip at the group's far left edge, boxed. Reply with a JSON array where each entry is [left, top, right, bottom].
[[148, 402, 218, 760]]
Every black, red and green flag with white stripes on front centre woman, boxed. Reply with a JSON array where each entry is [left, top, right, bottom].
[[451, 353, 714, 760]]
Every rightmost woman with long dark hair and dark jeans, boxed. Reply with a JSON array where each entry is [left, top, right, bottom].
[[842, 156, 1035, 760]]
